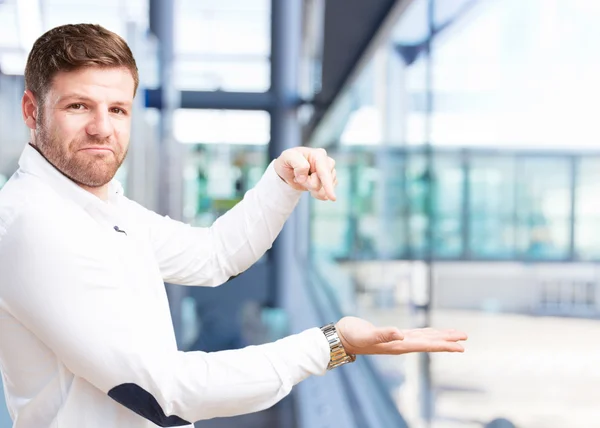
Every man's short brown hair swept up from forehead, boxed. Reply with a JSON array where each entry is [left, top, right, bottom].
[[25, 24, 139, 103]]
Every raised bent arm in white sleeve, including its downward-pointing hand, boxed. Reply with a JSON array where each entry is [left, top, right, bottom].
[[131, 147, 337, 286]]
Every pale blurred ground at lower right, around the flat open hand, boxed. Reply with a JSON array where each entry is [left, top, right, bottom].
[[358, 309, 600, 428]]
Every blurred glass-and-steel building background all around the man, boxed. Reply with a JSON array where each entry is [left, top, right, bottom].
[[0, 0, 600, 428]]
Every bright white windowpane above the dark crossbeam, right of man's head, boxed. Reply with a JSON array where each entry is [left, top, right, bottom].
[[175, 0, 271, 92]]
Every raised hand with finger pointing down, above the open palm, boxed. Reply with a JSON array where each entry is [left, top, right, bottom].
[[274, 147, 337, 201]]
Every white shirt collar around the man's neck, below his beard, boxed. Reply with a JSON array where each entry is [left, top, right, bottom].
[[19, 144, 123, 208]]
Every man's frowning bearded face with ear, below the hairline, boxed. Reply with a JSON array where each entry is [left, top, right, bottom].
[[24, 67, 134, 189]]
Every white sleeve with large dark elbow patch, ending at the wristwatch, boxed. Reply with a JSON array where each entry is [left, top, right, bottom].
[[0, 208, 329, 427]]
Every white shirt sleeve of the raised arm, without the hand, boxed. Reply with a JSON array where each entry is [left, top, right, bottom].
[[129, 163, 302, 286]]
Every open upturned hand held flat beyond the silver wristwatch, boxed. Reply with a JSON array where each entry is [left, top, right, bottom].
[[336, 317, 467, 355]]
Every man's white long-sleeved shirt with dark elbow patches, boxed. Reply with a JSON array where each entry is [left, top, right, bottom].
[[0, 146, 329, 428]]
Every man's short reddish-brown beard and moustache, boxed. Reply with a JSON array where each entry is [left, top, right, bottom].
[[35, 118, 127, 188]]
